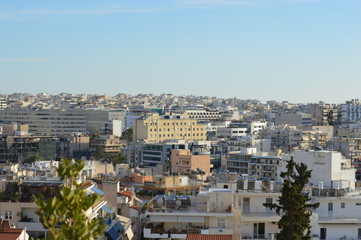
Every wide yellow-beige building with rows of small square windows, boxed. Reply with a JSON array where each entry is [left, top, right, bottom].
[[133, 115, 207, 142]]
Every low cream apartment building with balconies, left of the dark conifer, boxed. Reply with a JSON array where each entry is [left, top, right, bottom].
[[144, 180, 280, 240]]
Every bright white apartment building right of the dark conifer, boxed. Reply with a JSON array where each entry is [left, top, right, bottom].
[[283, 150, 361, 240]]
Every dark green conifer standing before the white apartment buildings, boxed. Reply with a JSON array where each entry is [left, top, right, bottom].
[[263, 158, 319, 240]]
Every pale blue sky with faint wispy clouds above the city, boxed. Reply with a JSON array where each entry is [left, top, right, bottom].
[[0, 0, 361, 103]]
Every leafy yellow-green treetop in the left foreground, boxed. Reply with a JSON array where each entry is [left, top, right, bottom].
[[36, 159, 104, 240]]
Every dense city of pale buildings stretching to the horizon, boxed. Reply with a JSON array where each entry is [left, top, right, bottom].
[[0, 93, 361, 240]]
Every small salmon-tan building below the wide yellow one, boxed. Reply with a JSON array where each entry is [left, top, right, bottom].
[[171, 149, 210, 174]]
